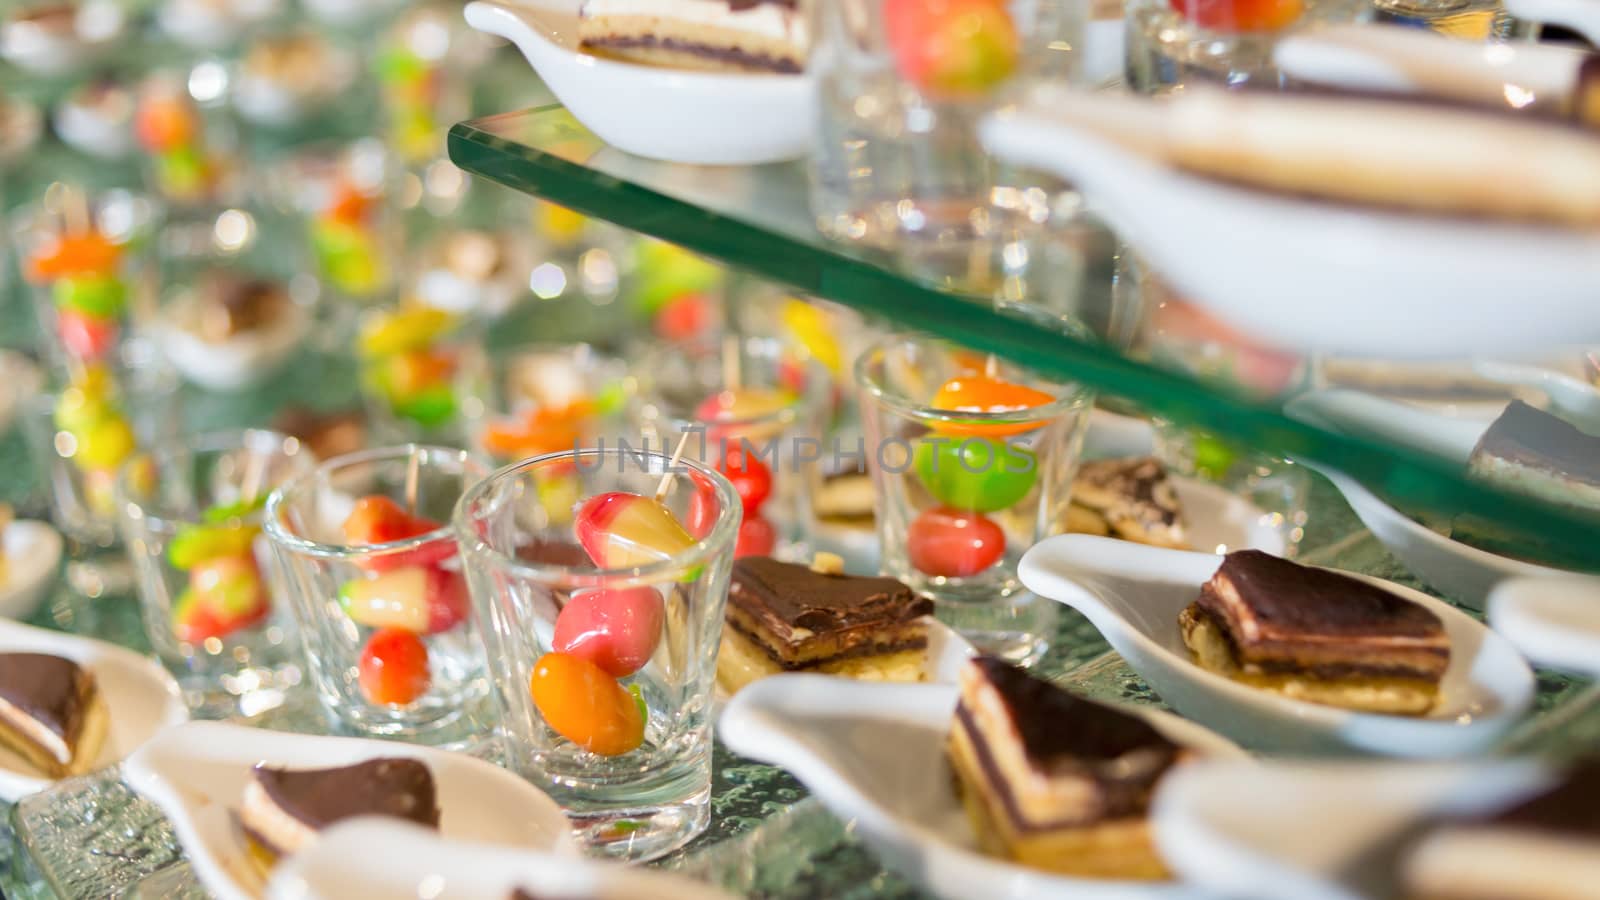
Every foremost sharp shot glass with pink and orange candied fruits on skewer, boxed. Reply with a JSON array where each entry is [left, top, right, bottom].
[[454, 448, 741, 862]]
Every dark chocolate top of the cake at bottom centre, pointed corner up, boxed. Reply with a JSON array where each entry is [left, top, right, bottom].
[[971, 657, 1178, 762]]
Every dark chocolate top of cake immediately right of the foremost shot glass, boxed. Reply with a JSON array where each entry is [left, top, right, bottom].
[[728, 556, 933, 636]]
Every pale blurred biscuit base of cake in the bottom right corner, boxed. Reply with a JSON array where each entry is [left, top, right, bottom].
[[1403, 826, 1600, 900]]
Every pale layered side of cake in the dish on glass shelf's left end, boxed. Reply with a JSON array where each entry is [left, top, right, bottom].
[[578, 16, 805, 74]]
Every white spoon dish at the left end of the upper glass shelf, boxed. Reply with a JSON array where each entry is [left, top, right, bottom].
[[466, 0, 816, 165]]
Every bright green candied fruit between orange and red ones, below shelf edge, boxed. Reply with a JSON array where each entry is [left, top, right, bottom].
[[914, 436, 1038, 512]]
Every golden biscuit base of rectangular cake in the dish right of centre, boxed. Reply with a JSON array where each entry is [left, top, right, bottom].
[[1179, 605, 1438, 716]]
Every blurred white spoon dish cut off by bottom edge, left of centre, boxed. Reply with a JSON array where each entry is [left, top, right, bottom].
[[267, 818, 731, 900]]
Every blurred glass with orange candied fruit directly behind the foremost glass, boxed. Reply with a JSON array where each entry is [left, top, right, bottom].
[[461, 343, 634, 464]]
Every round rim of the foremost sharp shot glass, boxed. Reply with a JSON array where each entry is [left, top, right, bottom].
[[450, 447, 742, 586]]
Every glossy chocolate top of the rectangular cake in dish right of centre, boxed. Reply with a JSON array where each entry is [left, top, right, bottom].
[[1198, 549, 1443, 641]]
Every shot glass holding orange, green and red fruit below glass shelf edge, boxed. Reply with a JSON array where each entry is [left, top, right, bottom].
[[856, 335, 1091, 663]]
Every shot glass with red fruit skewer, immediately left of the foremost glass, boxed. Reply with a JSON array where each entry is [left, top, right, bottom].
[[264, 445, 488, 743]]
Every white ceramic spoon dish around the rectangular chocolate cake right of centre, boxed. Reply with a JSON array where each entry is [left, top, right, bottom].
[[1018, 535, 1534, 757]]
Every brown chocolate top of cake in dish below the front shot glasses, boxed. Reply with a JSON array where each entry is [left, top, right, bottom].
[[254, 759, 438, 830]]
